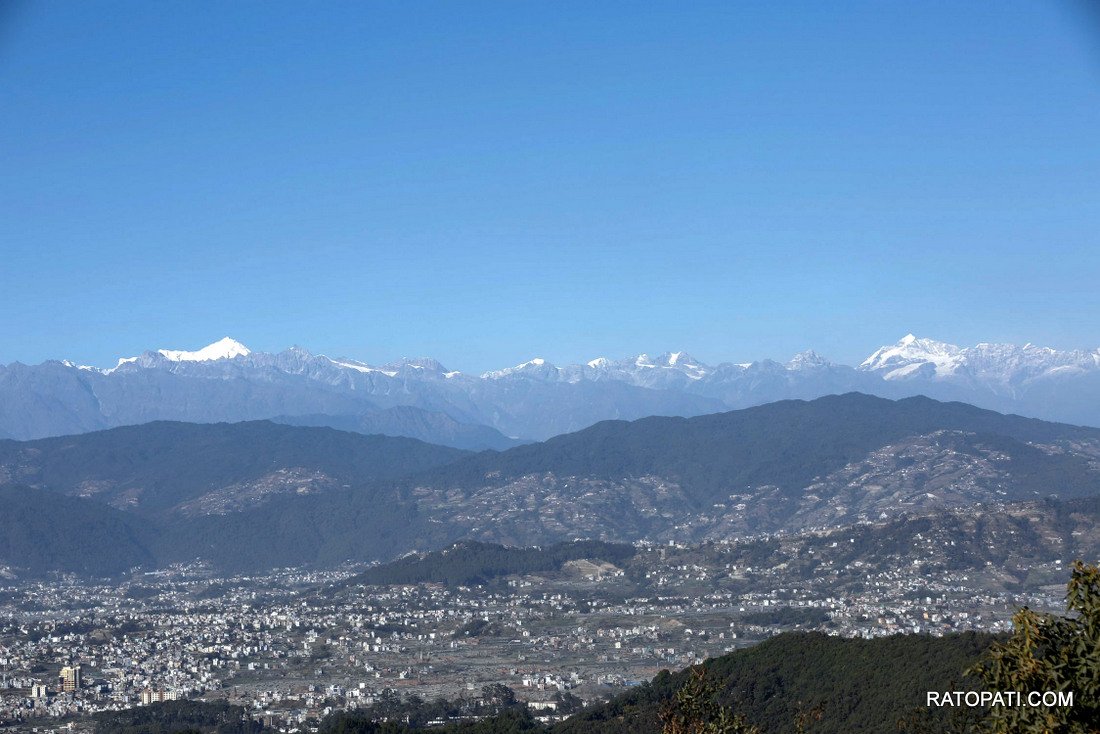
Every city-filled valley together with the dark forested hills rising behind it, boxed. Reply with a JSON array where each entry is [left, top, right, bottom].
[[0, 393, 1100, 732]]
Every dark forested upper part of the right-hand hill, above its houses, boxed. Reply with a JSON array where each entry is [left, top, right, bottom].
[[411, 393, 1100, 502]]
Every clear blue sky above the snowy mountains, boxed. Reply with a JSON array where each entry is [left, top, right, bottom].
[[0, 0, 1100, 371]]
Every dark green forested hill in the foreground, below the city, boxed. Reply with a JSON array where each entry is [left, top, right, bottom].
[[553, 633, 994, 734]]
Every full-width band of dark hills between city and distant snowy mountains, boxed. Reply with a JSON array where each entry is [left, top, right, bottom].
[[0, 393, 1100, 576]]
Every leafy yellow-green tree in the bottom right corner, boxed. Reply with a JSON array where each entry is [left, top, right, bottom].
[[968, 561, 1100, 734]]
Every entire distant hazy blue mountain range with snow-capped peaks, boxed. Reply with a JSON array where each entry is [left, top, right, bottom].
[[0, 335, 1100, 448]]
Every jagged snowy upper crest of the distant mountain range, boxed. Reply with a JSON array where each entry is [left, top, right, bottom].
[[42, 333, 1100, 398]]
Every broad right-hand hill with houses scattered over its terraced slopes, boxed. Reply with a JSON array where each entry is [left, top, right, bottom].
[[406, 393, 1100, 545]]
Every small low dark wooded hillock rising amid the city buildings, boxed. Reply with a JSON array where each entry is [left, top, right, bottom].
[[349, 540, 634, 585]]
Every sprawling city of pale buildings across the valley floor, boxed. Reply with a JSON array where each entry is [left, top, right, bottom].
[[0, 508, 1066, 732]]
